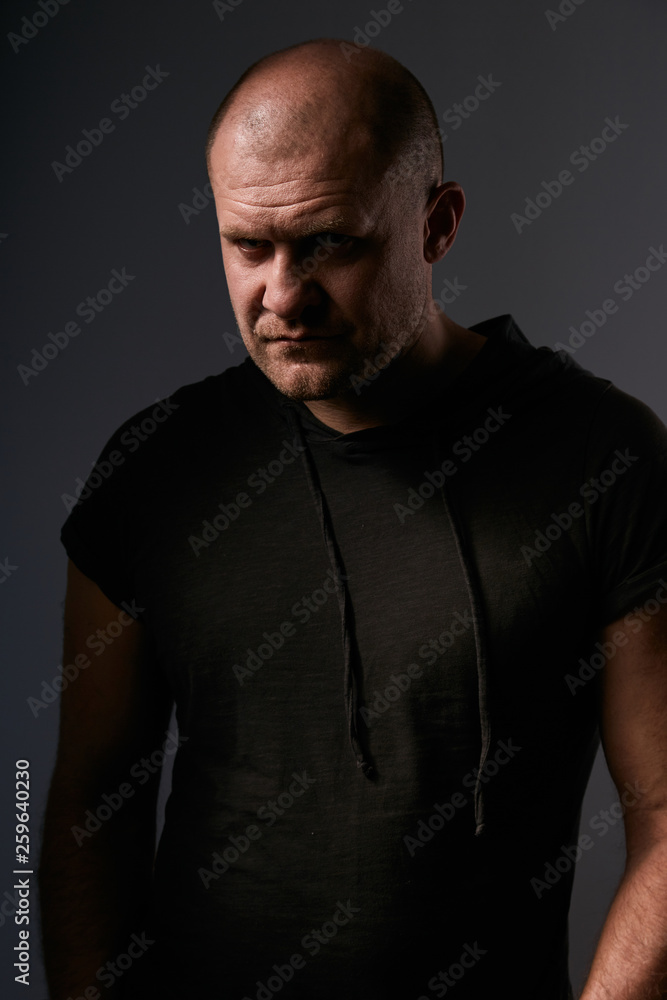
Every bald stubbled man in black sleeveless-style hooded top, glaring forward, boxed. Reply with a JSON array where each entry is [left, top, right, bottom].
[[42, 40, 667, 1000]]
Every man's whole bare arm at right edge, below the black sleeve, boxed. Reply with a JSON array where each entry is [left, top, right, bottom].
[[581, 605, 667, 1000]]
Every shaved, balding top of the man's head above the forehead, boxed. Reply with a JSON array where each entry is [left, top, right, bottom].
[[206, 39, 443, 199]]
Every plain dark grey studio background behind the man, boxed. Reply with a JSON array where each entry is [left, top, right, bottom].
[[0, 0, 667, 1000]]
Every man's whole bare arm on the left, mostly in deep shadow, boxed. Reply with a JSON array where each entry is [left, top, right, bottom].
[[39, 562, 171, 1000]]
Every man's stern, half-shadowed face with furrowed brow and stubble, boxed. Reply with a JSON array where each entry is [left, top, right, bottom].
[[210, 114, 430, 400]]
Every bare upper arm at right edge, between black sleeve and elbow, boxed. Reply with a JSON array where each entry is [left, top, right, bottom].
[[601, 605, 667, 852]]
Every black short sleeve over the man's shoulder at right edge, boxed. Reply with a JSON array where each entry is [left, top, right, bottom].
[[581, 385, 667, 625]]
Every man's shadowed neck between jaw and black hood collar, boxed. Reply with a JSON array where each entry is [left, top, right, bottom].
[[305, 313, 487, 434]]
